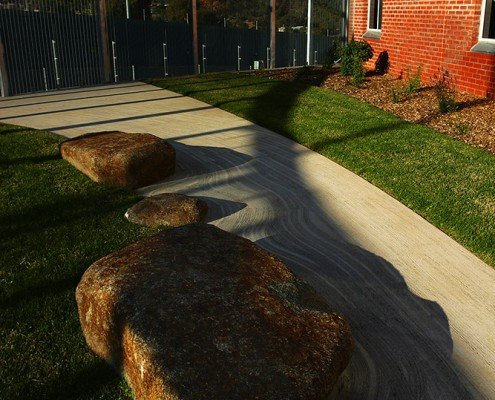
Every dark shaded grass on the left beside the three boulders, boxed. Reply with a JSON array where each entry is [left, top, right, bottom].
[[0, 125, 159, 400]]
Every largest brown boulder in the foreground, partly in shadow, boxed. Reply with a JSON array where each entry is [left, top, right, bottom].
[[76, 224, 353, 400]]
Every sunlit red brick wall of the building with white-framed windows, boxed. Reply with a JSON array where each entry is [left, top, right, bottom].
[[349, 0, 495, 97]]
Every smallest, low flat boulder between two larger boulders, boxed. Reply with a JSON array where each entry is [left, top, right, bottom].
[[125, 193, 208, 227]]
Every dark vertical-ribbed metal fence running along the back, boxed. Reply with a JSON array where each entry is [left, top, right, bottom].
[[0, 0, 342, 96]]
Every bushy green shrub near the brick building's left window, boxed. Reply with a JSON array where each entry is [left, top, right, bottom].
[[340, 38, 373, 86]]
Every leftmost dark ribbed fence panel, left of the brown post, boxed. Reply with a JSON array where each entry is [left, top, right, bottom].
[[0, 9, 102, 94]]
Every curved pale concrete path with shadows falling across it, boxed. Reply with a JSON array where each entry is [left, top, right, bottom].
[[0, 83, 495, 400]]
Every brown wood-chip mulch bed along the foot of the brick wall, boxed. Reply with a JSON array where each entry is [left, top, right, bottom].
[[250, 68, 495, 154]]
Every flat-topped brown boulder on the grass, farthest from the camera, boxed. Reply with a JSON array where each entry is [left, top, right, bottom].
[[60, 132, 175, 188]]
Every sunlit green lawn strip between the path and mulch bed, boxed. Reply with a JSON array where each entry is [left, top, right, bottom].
[[150, 69, 495, 266]]
